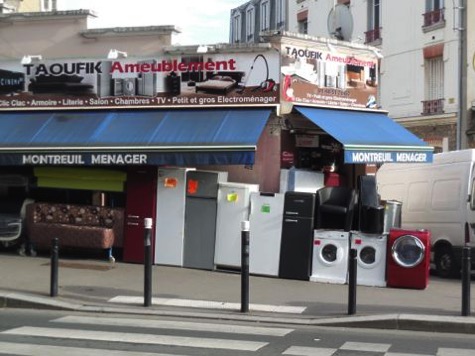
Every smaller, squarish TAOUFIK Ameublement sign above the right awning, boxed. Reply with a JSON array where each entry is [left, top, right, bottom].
[[281, 41, 378, 110]]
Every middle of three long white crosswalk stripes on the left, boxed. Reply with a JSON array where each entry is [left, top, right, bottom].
[[1, 326, 268, 351]]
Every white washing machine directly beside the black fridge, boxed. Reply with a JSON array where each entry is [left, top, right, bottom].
[[310, 230, 350, 284]]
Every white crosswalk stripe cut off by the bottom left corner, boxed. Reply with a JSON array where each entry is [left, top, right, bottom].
[[0, 342, 184, 356]]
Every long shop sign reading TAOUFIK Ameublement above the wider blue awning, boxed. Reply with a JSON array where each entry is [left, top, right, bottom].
[[0, 50, 280, 110]]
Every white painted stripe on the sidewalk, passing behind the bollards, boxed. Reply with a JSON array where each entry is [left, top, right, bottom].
[[109, 295, 306, 314]]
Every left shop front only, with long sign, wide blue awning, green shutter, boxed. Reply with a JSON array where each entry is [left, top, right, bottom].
[[0, 45, 279, 262]]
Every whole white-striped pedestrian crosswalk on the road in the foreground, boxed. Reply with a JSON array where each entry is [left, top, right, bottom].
[[0, 315, 475, 356]]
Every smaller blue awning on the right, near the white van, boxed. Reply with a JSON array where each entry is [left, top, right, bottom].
[[296, 106, 434, 163]]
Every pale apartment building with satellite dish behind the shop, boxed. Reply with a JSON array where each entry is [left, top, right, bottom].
[[230, 0, 475, 151]]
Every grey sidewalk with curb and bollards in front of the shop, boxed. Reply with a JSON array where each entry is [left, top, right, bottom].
[[0, 253, 475, 333]]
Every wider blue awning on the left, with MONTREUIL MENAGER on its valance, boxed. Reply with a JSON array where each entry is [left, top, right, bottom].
[[0, 108, 270, 166]]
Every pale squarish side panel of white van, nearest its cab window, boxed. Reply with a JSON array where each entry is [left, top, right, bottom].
[[431, 179, 463, 211]]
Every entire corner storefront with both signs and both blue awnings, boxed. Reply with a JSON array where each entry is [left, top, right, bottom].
[[0, 36, 432, 262]]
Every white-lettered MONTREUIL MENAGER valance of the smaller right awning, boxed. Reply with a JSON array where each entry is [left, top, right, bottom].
[[345, 150, 433, 164]]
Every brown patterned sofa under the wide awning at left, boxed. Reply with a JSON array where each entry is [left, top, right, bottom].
[[26, 203, 124, 261]]
